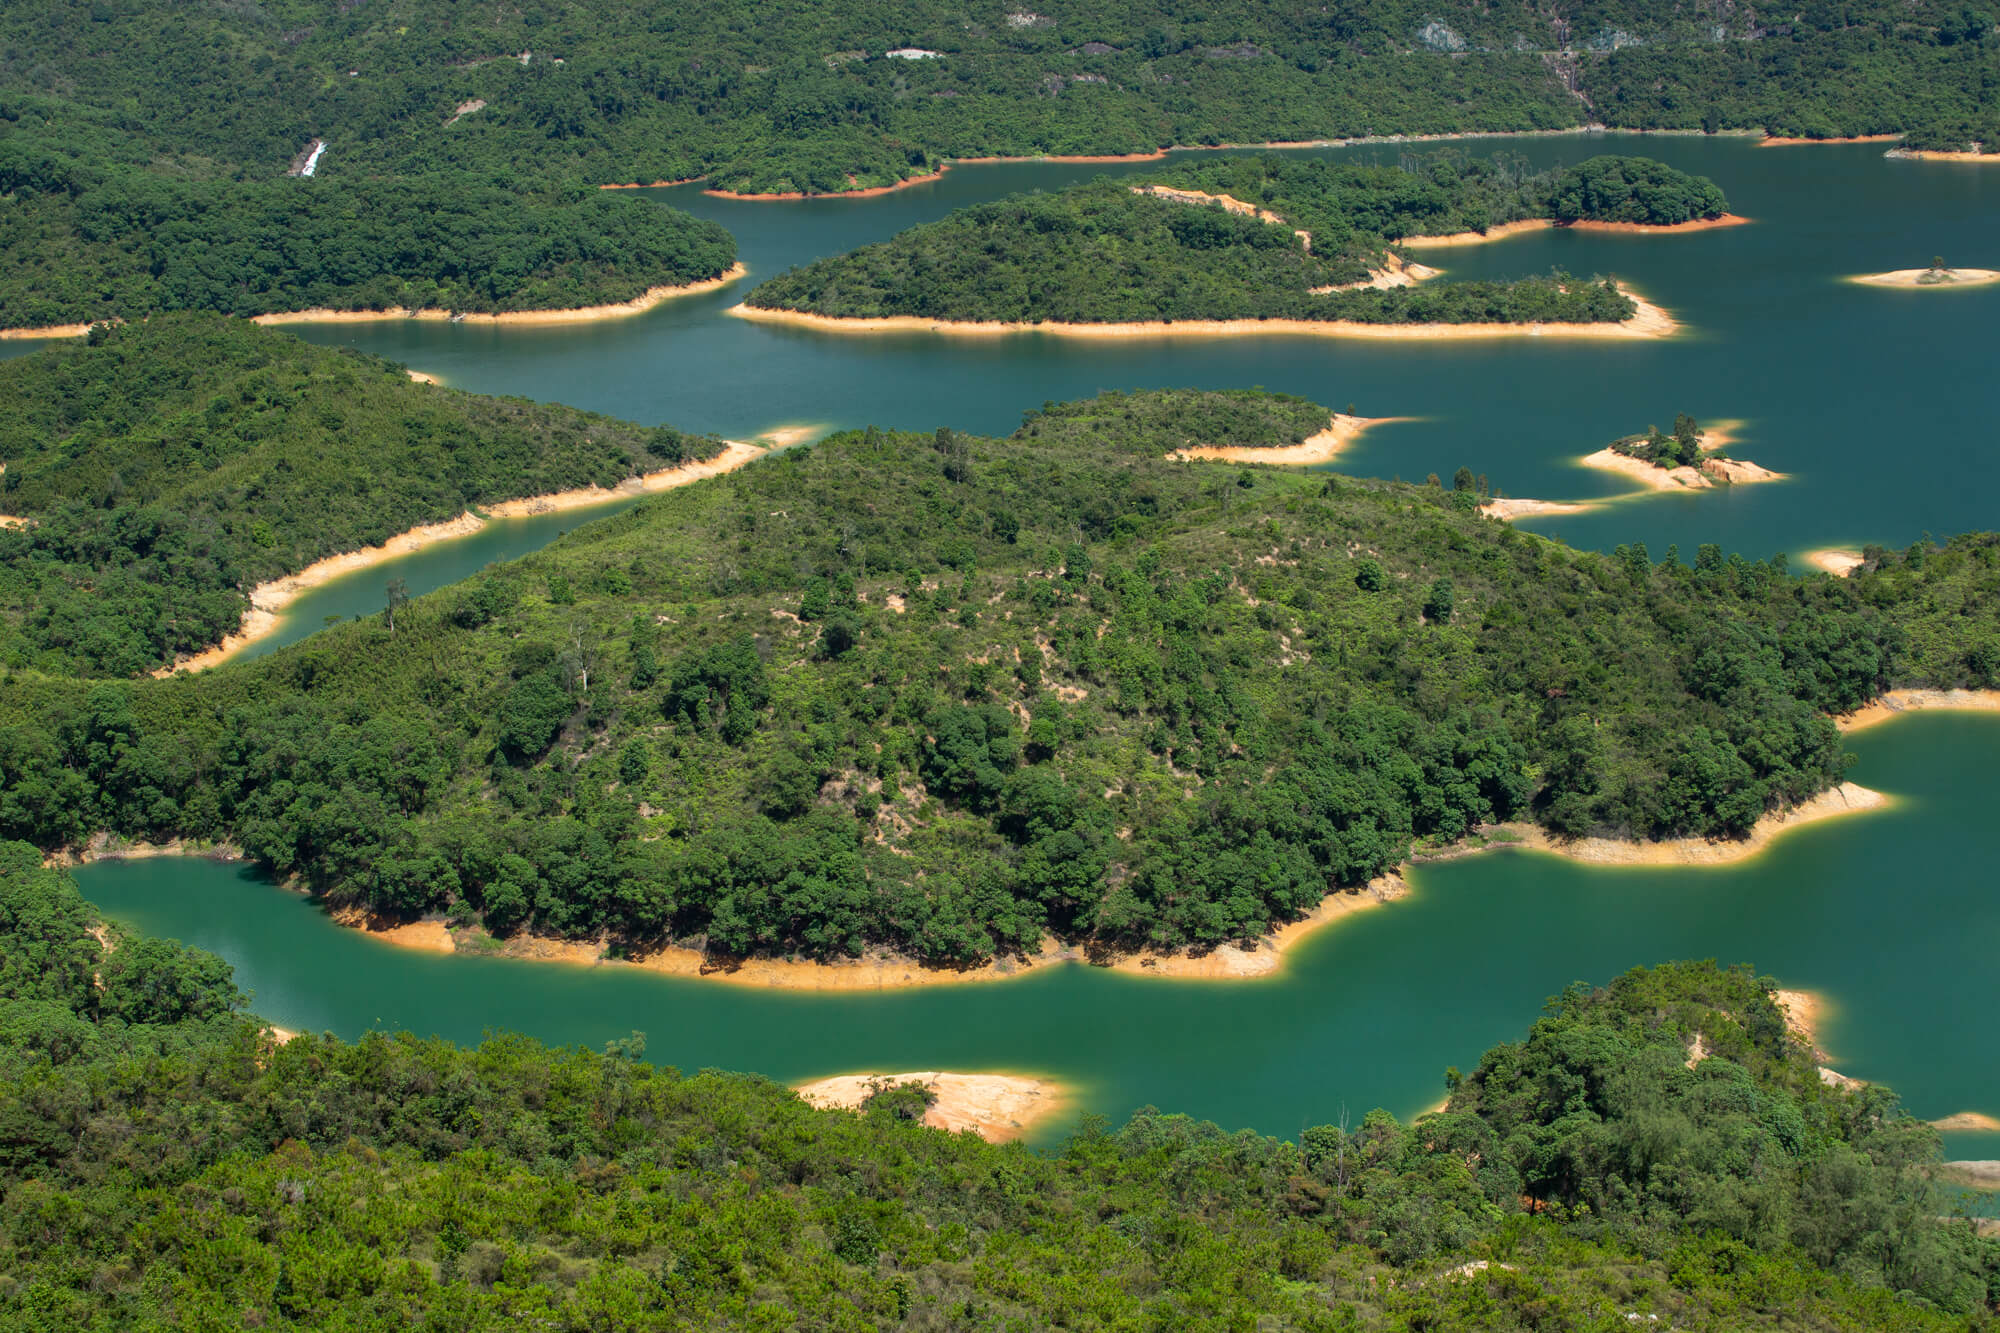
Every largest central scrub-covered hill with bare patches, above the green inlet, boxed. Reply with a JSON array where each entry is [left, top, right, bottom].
[[0, 392, 2000, 965]]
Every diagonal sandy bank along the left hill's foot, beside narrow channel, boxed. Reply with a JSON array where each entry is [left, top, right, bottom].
[[152, 440, 766, 677]]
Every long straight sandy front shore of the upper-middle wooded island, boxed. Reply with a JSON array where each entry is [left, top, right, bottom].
[[728, 284, 1680, 340]]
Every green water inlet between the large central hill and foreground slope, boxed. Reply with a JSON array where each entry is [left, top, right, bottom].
[[76, 713, 2000, 1157]]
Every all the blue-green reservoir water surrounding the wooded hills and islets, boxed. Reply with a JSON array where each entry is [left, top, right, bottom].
[[19, 136, 2000, 1157]]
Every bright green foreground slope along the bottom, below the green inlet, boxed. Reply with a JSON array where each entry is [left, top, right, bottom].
[[0, 843, 2000, 1333]]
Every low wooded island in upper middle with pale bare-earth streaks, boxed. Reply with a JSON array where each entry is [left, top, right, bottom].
[[746, 150, 1728, 324]]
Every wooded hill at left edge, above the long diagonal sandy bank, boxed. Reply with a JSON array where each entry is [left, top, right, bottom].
[[0, 316, 720, 677]]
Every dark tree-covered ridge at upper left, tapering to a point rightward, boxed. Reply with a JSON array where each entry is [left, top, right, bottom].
[[0, 128, 736, 328]]
